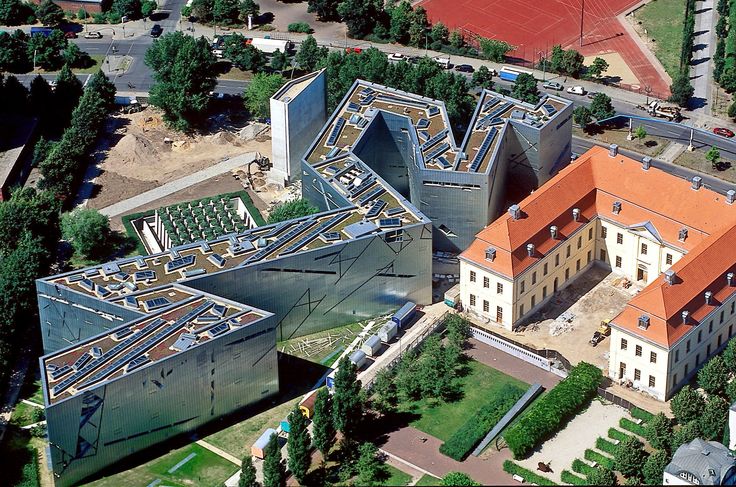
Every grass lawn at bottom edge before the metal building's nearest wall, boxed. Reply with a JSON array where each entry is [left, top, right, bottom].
[[87, 444, 238, 487]]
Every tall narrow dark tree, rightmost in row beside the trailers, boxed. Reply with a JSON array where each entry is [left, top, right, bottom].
[[332, 357, 363, 439]]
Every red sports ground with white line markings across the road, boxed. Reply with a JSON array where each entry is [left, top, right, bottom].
[[421, 0, 669, 94]]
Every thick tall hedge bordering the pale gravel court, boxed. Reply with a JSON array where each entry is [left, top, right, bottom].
[[504, 362, 603, 459]]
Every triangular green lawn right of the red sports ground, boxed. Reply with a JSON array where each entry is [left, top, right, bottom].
[[634, 0, 685, 78]]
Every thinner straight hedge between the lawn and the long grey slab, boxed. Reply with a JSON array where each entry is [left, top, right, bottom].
[[440, 384, 524, 462]]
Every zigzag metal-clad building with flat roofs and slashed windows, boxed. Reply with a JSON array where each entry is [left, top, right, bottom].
[[36, 73, 570, 486]]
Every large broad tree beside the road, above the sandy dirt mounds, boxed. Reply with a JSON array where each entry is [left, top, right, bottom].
[[145, 32, 216, 130]]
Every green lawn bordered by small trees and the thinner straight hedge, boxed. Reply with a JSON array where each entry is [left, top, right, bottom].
[[399, 360, 529, 441]]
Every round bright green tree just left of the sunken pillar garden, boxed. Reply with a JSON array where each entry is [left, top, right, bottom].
[[61, 208, 110, 258]]
